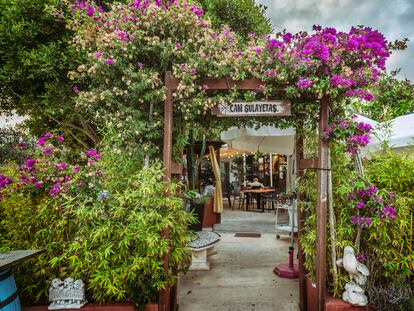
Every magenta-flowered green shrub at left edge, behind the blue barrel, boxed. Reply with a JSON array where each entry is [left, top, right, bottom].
[[0, 133, 92, 303]]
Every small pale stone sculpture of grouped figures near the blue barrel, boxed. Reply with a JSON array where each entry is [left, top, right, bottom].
[[48, 277, 86, 310]]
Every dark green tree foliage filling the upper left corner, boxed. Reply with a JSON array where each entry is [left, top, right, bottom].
[[0, 0, 98, 151]]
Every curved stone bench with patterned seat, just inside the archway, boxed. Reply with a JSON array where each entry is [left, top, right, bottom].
[[188, 231, 220, 270]]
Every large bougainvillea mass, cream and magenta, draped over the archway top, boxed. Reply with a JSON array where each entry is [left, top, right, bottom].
[[60, 0, 398, 129]]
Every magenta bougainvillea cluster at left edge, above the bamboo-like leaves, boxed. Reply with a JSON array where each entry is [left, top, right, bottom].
[[0, 133, 101, 200]]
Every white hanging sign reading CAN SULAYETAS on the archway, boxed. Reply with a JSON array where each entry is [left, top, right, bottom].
[[211, 100, 291, 117]]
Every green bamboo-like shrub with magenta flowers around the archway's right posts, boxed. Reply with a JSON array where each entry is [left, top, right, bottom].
[[300, 144, 414, 302]]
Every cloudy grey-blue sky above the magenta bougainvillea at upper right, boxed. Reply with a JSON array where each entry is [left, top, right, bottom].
[[256, 0, 414, 81]]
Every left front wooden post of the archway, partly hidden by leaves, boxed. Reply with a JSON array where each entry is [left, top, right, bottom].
[[159, 72, 174, 311]]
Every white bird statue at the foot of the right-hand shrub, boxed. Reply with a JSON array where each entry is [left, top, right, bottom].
[[336, 246, 369, 306]]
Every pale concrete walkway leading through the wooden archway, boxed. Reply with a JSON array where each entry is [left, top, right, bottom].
[[178, 212, 299, 311]]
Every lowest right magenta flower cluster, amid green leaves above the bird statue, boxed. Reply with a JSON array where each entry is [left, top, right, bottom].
[[347, 178, 396, 227]]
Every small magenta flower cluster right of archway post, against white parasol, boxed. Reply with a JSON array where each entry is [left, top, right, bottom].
[[322, 118, 373, 154]]
